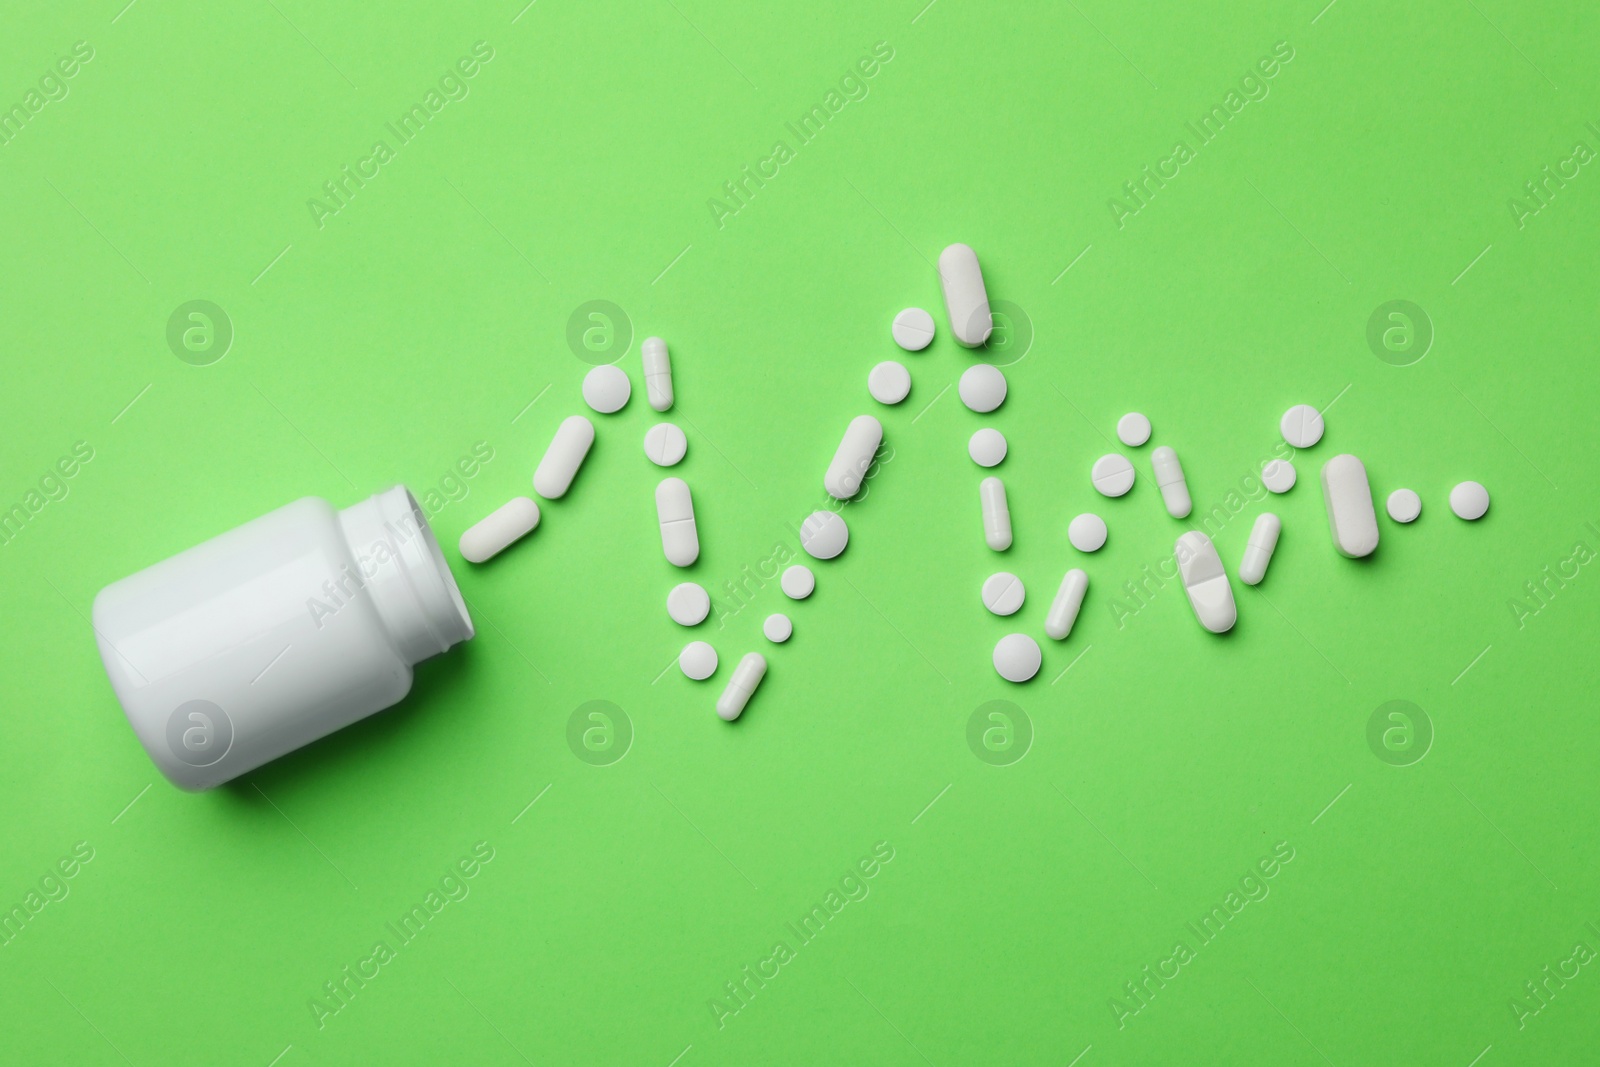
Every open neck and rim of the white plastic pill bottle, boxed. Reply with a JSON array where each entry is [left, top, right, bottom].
[[339, 485, 474, 664]]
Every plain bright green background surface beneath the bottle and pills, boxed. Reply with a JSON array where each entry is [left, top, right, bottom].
[[0, 0, 1600, 1067]]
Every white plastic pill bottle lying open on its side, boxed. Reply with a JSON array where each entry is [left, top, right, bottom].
[[94, 486, 472, 790]]
